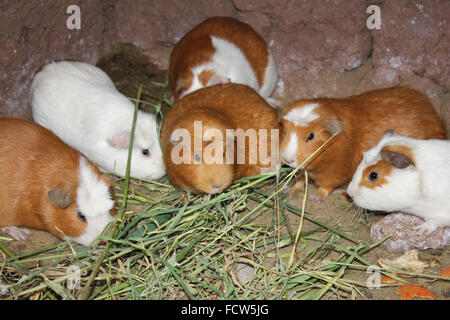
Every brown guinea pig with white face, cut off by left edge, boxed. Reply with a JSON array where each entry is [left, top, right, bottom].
[[0, 118, 115, 246]]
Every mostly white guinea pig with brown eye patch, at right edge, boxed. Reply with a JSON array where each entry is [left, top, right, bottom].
[[347, 131, 450, 230]]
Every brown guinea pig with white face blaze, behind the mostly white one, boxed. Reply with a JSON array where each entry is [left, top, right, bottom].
[[280, 87, 445, 200]]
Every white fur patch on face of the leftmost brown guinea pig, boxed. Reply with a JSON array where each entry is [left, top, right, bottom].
[[66, 156, 114, 246]]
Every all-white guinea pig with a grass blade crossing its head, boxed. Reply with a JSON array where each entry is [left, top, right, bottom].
[[31, 61, 165, 180]]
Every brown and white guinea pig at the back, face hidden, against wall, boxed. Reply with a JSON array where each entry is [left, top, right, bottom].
[[169, 17, 278, 100]]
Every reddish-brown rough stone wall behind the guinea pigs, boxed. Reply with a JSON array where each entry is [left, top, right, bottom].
[[0, 0, 450, 132]]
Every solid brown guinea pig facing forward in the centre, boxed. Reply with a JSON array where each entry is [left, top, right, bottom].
[[161, 83, 279, 194]]
